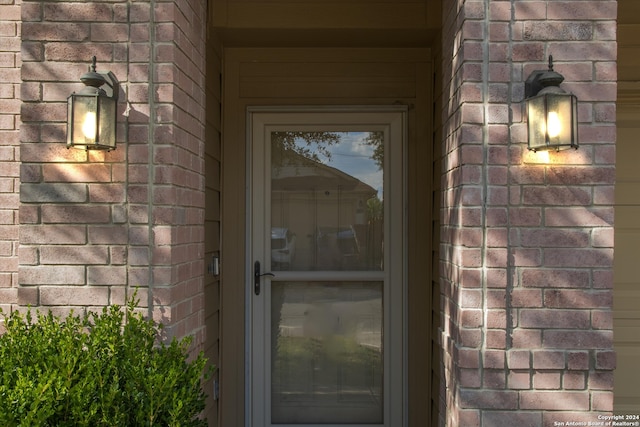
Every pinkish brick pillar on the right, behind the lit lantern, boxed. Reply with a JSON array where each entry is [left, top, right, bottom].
[[441, 0, 616, 427]]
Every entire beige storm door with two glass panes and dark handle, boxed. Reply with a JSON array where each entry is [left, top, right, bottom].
[[247, 108, 406, 427]]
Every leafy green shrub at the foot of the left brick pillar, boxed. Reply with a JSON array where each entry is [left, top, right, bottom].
[[0, 299, 215, 427]]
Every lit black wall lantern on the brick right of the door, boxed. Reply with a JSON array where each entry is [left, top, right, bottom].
[[525, 55, 578, 151]]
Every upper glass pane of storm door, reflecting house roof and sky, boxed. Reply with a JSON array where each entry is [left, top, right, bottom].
[[270, 131, 384, 271]]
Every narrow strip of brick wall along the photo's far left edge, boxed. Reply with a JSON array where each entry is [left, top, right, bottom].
[[0, 0, 20, 320]]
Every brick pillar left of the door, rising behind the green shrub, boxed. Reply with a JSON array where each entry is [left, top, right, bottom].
[[18, 0, 206, 344]]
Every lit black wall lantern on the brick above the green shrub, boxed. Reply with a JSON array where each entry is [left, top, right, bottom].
[[67, 56, 120, 150]]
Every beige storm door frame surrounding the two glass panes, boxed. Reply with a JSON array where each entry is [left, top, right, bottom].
[[245, 106, 408, 427]]
